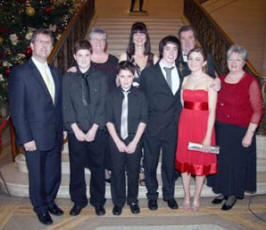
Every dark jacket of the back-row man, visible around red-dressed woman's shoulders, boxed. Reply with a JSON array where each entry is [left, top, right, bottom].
[[176, 52, 216, 78]]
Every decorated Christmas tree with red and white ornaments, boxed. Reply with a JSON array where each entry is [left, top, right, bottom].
[[0, 0, 74, 103]]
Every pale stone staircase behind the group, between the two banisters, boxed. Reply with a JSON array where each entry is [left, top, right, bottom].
[[0, 17, 266, 198]]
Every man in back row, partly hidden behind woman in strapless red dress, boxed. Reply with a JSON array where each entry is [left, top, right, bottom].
[[177, 25, 215, 78]]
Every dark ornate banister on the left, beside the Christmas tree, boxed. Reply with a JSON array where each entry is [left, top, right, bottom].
[[9, 0, 95, 161]]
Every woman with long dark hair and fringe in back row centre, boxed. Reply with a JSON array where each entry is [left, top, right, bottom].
[[119, 22, 159, 186]]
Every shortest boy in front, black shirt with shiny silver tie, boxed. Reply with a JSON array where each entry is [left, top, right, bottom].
[[107, 61, 147, 215]]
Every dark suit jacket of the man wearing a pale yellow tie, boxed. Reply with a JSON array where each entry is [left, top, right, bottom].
[[8, 59, 63, 151]]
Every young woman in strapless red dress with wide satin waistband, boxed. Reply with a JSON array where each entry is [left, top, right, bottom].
[[175, 48, 217, 211]]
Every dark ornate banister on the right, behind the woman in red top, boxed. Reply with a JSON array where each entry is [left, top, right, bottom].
[[184, 0, 266, 135]]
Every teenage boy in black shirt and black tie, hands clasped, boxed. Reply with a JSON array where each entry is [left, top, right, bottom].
[[63, 40, 107, 216]]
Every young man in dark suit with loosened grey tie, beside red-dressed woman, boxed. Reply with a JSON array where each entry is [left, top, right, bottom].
[[140, 36, 183, 210]]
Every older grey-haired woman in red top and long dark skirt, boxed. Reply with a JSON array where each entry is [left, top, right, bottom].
[[208, 45, 263, 210]]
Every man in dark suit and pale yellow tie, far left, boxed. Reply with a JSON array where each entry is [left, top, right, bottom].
[[9, 29, 63, 225]]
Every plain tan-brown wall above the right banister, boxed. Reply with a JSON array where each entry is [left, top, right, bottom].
[[202, 0, 266, 76]]
